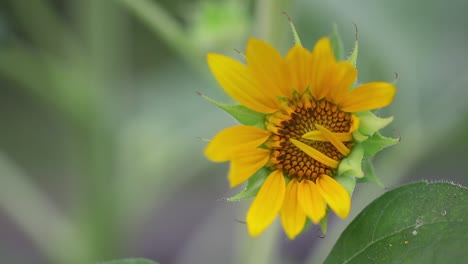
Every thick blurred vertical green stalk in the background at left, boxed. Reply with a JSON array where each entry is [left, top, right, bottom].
[[69, 0, 128, 263]]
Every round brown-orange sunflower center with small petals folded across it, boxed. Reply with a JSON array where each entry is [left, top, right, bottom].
[[266, 92, 352, 180]]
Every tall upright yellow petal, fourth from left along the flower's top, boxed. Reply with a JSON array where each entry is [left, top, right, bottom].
[[310, 38, 336, 100]]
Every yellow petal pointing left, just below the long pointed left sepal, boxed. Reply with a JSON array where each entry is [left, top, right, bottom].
[[205, 126, 269, 162]]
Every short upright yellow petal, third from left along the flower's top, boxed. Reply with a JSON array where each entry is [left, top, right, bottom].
[[286, 45, 312, 94]]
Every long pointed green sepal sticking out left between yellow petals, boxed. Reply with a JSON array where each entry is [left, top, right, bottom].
[[201, 95, 265, 129]]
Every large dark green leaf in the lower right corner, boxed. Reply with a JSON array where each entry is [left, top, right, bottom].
[[325, 182, 468, 264]]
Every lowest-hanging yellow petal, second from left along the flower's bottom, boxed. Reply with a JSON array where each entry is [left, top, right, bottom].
[[280, 179, 306, 240]]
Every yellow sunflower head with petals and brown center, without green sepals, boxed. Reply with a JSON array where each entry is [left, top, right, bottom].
[[205, 38, 395, 239]]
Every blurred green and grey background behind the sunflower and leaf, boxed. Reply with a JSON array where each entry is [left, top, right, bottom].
[[0, 0, 468, 264]]
